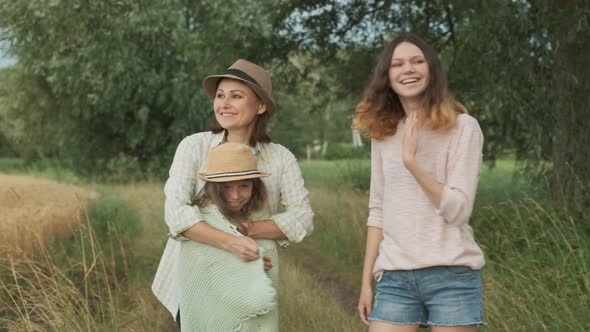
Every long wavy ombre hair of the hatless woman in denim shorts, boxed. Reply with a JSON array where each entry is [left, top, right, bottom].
[[352, 32, 467, 140]]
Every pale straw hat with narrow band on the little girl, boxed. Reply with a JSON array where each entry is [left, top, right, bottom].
[[198, 143, 270, 182]]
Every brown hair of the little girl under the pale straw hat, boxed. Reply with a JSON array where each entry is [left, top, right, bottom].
[[192, 178, 267, 223]]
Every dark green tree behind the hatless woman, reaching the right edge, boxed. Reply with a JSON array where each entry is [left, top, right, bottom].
[[279, 0, 590, 206]]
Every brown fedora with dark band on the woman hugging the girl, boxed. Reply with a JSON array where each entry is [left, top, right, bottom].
[[203, 59, 276, 114]]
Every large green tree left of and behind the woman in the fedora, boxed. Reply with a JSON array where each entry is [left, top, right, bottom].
[[0, 0, 284, 173]]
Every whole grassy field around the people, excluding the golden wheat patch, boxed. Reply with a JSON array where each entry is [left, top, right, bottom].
[[0, 161, 590, 332]]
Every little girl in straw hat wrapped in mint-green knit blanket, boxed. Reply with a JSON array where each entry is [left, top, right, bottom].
[[179, 143, 278, 332]]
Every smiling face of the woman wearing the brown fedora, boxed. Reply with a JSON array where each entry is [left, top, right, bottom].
[[213, 79, 265, 133]]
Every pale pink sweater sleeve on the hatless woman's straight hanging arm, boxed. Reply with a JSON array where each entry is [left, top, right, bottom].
[[367, 140, 385, 228]]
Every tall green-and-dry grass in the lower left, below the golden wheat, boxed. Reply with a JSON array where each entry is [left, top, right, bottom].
[[0, 180, 162, 331]]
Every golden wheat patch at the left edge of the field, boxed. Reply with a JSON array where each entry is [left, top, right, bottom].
[[0, 174, 98, 253]]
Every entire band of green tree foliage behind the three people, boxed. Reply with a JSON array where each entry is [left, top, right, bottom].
[[0, 0, 590, 208]]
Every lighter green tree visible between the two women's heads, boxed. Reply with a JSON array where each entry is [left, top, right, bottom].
[[272, 51, 364, 158]]
